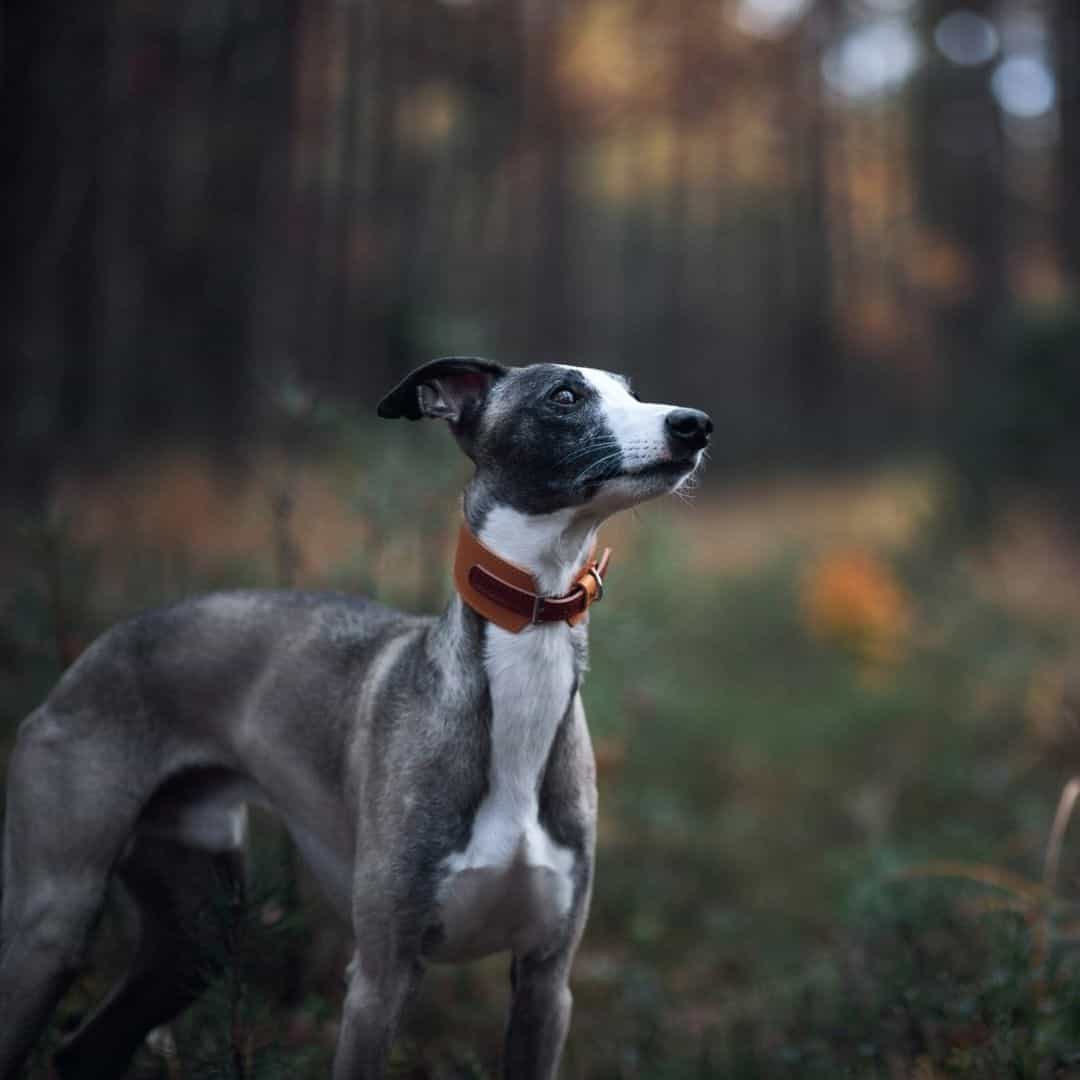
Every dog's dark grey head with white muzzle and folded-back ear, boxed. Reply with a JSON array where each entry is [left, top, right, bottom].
[[379, 356, 713, 516]]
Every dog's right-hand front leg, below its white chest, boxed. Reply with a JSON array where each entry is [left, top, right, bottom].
[[502, 949, 573, 1080]]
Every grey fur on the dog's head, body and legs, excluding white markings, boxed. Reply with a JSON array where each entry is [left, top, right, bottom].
[[0, 359, 707, 1080]]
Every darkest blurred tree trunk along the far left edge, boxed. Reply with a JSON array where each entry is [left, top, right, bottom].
[[0, 0, 106, 501]]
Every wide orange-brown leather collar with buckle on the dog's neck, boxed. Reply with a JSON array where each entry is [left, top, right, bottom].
[[454, 522, 611, 634]]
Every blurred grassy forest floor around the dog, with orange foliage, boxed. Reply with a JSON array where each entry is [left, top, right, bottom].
[[0, 434, 1080, 1080]]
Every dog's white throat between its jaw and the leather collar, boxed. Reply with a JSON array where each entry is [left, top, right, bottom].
[[464, 491, 599, 596]]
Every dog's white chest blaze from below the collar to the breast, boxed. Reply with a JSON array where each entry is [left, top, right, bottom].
[[435, 624, 575, 960]]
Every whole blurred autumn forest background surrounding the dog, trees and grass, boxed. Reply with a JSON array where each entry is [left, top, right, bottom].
[[0, 0, 1080, 1080]]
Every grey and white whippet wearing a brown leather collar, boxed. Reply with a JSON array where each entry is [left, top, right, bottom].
[[0, 357, 712, 1080]]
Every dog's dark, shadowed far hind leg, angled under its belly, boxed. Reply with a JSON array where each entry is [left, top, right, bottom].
[[56, 837, 243, 1080]]
